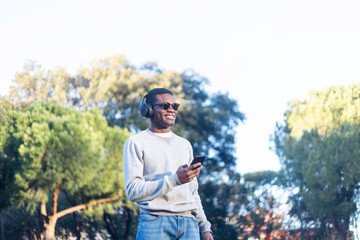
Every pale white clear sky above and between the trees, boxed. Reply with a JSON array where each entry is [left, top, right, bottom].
[[0, 0, 360, 173]]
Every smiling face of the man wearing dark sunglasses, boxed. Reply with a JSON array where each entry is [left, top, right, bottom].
[[151, 93, 177, 131]]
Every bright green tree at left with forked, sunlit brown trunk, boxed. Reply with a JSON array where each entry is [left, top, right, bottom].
[[0, 104, 129, 240]]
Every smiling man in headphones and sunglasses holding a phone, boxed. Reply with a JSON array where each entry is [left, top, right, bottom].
[[124, 88, 213, 240]]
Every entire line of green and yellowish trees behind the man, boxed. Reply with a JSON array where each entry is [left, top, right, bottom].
[[0, 56, 360, 239]]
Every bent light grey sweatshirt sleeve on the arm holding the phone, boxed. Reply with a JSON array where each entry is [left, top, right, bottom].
[[123, 137, 180, 202]]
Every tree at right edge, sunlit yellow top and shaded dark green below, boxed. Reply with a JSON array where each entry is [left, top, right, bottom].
[[274, 84, 360, 239]]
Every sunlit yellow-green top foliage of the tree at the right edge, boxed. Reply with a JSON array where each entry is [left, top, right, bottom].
[[286, 84, 360, 138]]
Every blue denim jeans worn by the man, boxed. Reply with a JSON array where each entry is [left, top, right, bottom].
[[136, 213, 200, 240]]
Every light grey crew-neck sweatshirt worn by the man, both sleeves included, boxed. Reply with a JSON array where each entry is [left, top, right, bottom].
[[124, 129, 211, 232]]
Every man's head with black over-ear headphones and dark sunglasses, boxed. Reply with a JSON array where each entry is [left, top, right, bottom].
[[140, 88, 179, 132]]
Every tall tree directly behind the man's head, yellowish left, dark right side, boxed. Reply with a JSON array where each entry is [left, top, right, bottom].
[[2, 56, 245, 237]]
